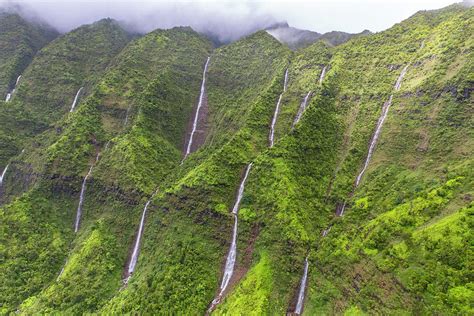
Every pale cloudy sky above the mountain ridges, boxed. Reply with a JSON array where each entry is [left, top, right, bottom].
[[0, 0, 460, 41]]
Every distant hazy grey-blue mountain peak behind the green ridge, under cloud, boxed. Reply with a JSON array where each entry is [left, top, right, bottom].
[[267, 23, 371, 49]]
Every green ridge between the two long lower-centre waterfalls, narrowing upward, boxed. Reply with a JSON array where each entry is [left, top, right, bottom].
[[104, 33, 288, 314]]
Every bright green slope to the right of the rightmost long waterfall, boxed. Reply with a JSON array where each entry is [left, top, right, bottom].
[[306, 6, 473, 314]]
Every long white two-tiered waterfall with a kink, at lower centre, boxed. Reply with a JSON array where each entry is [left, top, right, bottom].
[[208, 163, 252, 313]]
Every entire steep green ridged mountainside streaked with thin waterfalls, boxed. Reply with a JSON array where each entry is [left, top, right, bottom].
[[0, 5, 474, 315]]
